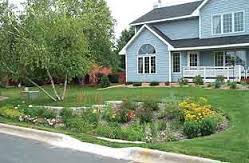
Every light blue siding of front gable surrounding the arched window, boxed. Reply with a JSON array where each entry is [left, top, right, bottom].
[[127, 29, 169, 82]]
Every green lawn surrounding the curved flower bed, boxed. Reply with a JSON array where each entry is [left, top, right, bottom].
[[0, 87, 249, 163]]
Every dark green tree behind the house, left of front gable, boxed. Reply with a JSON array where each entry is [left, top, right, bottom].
[[115, 27, 135, 69]]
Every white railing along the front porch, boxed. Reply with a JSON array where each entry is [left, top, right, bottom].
[[183, 65, 244, 81]]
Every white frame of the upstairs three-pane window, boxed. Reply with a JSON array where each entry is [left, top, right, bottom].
[[211, 10, 246, 36]]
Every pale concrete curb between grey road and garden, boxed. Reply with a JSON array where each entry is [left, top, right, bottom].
[[0, 123, 220, 163]]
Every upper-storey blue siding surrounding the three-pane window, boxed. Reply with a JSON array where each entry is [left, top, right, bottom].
[[200, 0, 249, 38]]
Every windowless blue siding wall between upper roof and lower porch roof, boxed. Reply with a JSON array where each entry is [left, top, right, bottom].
[[153, 18, 199, 40]]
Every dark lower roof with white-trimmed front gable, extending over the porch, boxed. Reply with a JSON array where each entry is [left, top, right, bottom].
[[119, 24, 249, 55]]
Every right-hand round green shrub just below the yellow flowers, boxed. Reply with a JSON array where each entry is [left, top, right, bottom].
[[199, 118, 218, 136]]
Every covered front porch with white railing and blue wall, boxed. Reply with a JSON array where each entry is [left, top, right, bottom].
[[171, 49, 249, 82]]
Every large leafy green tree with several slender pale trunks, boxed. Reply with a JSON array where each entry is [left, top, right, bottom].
[[0, 0, 92, 101]]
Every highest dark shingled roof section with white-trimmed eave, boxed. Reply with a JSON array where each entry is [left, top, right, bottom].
[[131, 0, 204, 25]]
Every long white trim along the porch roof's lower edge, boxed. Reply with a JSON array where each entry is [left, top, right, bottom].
[[173, 43, 249, 51]]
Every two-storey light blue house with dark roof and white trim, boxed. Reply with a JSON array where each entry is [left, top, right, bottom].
[[120, 0, 249, 82]]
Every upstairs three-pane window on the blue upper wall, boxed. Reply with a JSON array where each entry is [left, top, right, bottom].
[[212, 12, 245, 34]]
